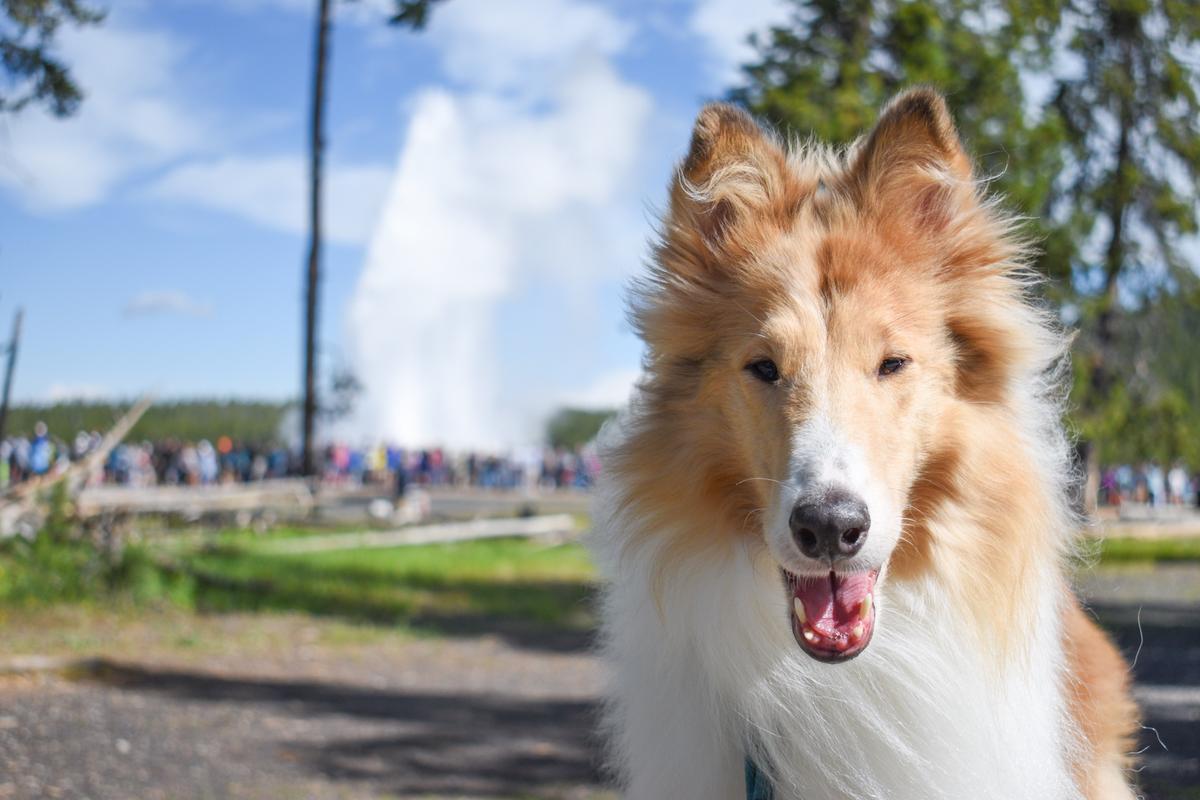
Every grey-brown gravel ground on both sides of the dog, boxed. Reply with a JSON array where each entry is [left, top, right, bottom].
[[0, 565, 1200, 800]]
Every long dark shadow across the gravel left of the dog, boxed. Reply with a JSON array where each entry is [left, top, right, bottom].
[[94, 662, 602, 798]]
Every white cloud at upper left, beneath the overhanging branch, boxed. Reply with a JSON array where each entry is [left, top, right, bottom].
[[0, 20, 212, 211]]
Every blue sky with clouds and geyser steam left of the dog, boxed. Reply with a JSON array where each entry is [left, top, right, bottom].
[[0, 0, 787, 446]]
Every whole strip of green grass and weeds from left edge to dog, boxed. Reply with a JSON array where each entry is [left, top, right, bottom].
[[0, 528, 594, 634]]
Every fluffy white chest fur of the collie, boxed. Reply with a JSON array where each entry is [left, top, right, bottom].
[[610, 537, 1079, 800]]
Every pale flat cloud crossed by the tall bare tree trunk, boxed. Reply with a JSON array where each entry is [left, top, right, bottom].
[[146, 156, 391, 245]]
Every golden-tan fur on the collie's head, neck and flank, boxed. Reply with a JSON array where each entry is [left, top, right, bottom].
[[607, 89, 1136, 800]]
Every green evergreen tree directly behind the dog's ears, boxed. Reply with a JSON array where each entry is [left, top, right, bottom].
[[731, 0, 1070, 284]]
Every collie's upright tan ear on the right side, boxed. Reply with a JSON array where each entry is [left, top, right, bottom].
[[851, 88, 977, 234]]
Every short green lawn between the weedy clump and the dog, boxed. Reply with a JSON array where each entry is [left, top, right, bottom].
[[182, 531, 593, 632]]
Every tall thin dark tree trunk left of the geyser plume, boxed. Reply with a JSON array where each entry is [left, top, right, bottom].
[[301, 0, 330, 476]]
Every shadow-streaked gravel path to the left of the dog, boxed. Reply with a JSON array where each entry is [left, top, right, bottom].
[[0, 620, 601, 799]]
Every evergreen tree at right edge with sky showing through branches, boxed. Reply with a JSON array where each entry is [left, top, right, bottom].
[[1048, 0, 1200, 455]]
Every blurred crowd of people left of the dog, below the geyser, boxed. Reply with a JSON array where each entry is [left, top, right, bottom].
[[0, 422, 600, 491]]
